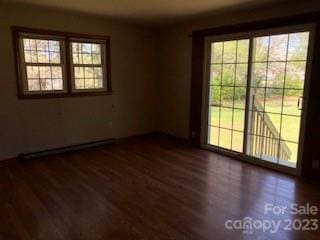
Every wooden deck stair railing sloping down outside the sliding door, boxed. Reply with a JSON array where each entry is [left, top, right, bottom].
[[249, 95, 291, 161]]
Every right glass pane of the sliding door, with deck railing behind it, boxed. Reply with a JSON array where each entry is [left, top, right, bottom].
[[246, 32, 309, 167]]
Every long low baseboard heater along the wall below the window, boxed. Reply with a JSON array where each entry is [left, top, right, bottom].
[[19, 138, 116, 160]]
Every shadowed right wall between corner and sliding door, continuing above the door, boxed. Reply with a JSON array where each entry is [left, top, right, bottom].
[[157, 0, 320, 138]]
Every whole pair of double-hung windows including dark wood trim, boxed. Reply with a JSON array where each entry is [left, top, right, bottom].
[[12, 27, 111, 98]]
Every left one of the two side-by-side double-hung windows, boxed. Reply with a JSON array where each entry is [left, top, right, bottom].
[[19, 34, 66, 94]]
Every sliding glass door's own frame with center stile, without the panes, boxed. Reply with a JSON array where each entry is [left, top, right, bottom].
[[201, 24, 315, 176]]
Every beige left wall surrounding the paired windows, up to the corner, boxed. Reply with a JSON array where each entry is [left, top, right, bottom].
[[0, 2, 156, 159]]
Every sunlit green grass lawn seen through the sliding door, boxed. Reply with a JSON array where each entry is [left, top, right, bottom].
[[210, 97, 301, 162]]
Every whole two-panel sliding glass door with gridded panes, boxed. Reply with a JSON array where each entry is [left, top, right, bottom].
[[204, 26, 312, 172]]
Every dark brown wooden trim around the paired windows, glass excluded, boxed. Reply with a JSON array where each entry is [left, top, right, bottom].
[[11, 26, 112, 99]]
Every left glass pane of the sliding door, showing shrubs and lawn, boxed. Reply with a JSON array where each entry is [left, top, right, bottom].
[[208, 39, 250, 152]]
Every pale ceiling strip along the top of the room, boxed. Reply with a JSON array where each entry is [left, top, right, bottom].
[[6, 0, 281, 25]]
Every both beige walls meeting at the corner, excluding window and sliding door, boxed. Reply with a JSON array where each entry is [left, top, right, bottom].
[[0, 0, 320, 159]]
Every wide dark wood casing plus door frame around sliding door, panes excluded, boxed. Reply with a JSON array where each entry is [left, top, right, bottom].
[[190, 12, 320, 175]]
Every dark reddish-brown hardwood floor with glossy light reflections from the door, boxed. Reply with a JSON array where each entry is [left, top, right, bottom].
[[0, 136, 320, 240]]
